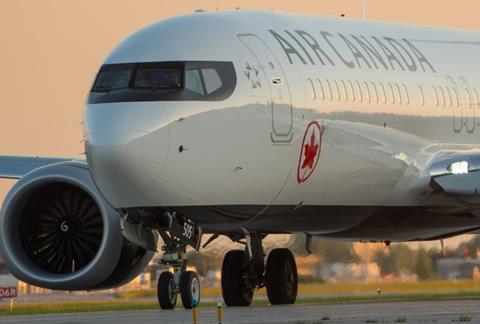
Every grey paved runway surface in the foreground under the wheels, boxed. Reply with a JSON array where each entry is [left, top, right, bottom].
[[0, 300, 480, 324]]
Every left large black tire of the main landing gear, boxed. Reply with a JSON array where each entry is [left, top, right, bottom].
[[221, 250, 253, 306]]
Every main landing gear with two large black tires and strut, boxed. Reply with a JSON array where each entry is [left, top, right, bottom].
[[221, 233, 298, 306]]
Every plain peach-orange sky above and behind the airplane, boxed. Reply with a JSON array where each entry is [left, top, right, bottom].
[[0, 0, 480, 248]]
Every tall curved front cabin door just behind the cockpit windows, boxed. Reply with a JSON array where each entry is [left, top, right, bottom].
[[238, 34, 293, 143]]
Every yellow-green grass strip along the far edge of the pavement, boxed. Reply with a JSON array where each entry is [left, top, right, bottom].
[[0, 280, 480, 316]]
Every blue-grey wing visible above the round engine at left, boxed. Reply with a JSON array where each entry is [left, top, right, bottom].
[[0, 155, 74, 179]]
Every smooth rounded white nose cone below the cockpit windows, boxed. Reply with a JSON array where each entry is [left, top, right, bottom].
[[85, 103, 169, 208]]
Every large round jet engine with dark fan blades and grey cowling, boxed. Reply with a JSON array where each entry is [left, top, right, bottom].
[[0, 161, 153, 290]]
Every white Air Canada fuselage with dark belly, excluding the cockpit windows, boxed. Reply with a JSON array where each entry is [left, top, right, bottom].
[[86, 11, 480, 240]]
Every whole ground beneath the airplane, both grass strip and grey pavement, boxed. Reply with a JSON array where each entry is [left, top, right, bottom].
[[0, 280, 480, 324]]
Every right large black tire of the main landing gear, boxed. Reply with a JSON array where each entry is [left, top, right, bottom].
[[265, 249, 298, 305]]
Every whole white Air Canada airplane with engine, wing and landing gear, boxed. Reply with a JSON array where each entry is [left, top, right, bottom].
[[0, 10, 480, 309]]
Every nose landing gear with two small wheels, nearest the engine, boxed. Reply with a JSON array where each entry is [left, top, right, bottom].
[[157, 230, 200, 309]]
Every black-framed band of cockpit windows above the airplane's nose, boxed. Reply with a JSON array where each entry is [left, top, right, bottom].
[[88, 61, 237, 104]]
